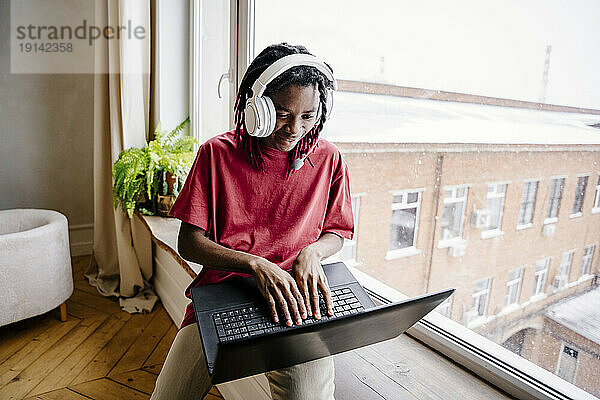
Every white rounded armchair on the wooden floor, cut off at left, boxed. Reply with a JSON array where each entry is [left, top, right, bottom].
[[0, 209, 73, 326]]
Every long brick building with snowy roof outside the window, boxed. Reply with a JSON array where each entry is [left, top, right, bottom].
[[326, 87, 600, 394]]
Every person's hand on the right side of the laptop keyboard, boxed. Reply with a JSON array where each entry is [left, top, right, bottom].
[[293, 246, 333, 319]]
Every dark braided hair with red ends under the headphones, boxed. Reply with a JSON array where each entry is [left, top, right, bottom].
[[234, 43, 333, 176]]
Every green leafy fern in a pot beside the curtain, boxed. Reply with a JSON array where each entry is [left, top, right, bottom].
[[113, 118, 196, 218]]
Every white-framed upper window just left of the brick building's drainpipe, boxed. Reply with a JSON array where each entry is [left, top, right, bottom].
[[388, 191, 421, 251]]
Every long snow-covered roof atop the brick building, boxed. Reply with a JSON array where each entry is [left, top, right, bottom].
[[323, 92, 600, 145]]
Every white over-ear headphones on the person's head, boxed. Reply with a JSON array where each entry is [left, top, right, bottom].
[[244, 54, 337, 137]]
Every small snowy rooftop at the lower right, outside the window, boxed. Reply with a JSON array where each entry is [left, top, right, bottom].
[[546, 288, 600, 344]]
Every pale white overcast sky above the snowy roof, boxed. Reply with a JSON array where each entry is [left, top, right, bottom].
[[255, 0, 600, 109]]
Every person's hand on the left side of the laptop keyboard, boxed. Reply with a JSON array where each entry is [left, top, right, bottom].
[[251, 257, 307, 326]]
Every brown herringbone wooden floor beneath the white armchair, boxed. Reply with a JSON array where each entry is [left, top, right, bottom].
[[0, 257, 223, 400]]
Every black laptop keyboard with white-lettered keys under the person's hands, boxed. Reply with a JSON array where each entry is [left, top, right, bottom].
[[213, 288, 365, 342]]
